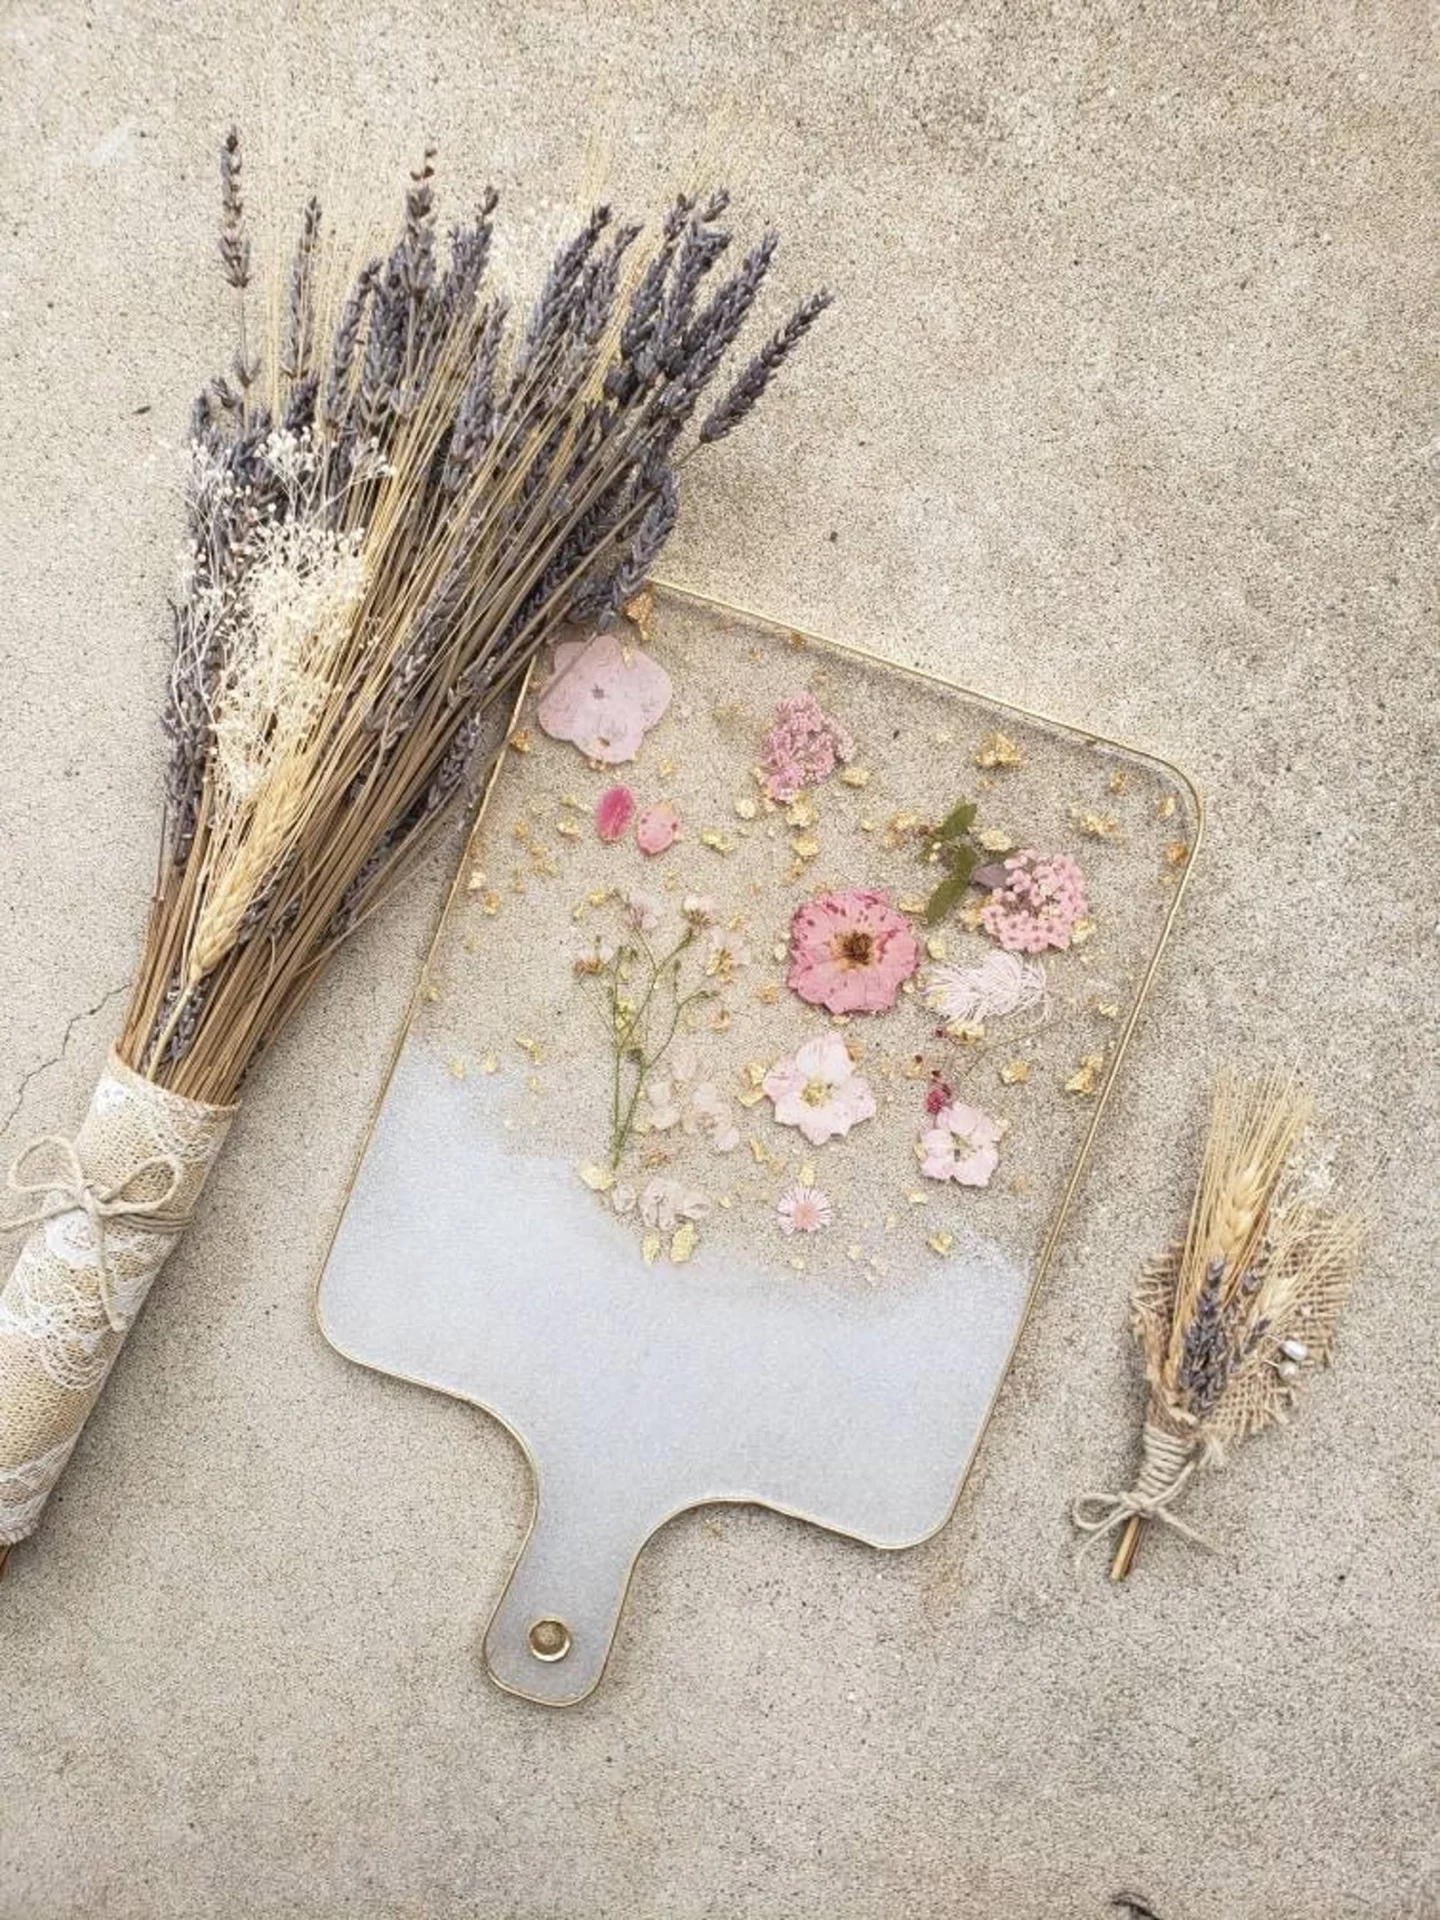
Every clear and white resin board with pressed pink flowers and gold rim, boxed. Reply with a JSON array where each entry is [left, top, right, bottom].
[[319, 589, 1200, 1705]]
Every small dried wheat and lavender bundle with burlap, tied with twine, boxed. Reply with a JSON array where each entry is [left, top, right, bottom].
[[1075, 1073, 1361, 1580]]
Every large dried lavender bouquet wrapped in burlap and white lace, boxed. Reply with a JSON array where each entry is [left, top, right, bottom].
[[0, 132, 829, 1565]]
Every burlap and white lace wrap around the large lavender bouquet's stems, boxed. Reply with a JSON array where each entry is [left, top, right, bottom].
[[0, 1054, 234, 1546]]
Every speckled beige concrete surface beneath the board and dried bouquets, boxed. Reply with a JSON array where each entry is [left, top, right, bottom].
[[0, 0, 1440, 1920]]
